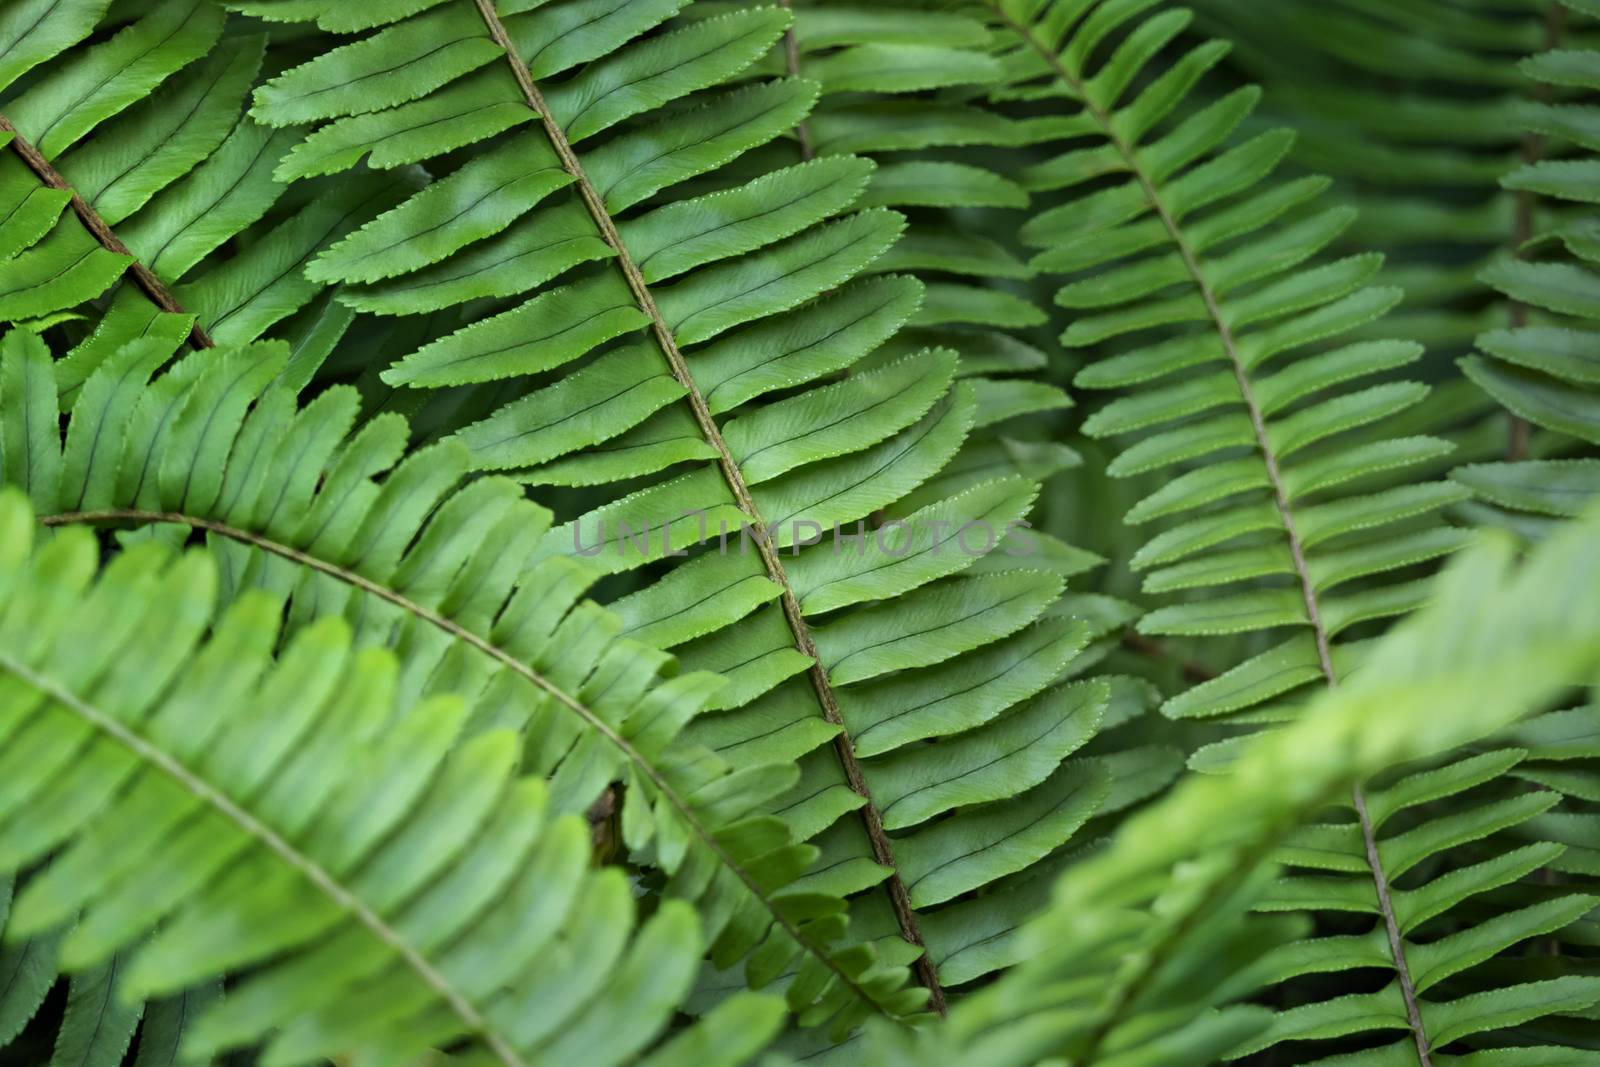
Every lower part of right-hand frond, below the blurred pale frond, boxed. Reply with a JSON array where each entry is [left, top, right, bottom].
[[1240, 749, 1600, 1064]]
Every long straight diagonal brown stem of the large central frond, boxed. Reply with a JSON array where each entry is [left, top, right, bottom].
[[474, 0, 946, 1014]]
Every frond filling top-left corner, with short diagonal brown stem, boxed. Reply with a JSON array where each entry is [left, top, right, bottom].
[[0, 0, 392, 363]]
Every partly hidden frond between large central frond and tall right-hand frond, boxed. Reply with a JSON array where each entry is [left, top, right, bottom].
[[752, 0, 1082, 534]]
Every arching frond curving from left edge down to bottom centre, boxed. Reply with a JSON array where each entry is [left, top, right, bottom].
[[0, 331, 899, 1036]]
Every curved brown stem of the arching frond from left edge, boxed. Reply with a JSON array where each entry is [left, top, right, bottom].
[[38, 509, 877, 1003]]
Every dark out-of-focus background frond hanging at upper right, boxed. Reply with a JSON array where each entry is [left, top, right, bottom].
[[1194, 0, 1542, 355]]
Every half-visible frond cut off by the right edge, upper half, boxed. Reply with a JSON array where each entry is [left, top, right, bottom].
[[1451, 0, 1600, 533]]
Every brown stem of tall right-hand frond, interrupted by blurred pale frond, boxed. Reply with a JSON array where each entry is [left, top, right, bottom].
[[987, 0, 1434, 1067]]
